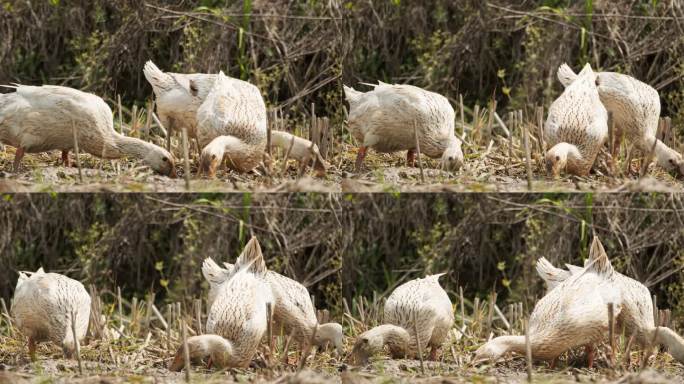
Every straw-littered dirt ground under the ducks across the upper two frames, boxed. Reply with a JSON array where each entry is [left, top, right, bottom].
[[0, 145, 684, 193]]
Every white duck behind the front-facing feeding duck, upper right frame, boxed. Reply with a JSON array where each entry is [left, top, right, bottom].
[[558, 64, 684, 175]]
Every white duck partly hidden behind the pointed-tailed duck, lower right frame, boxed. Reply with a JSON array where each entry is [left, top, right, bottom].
[[537, 257, 684, 365]]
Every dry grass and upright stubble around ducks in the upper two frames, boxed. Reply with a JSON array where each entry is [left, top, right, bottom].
[[0, 109, 684, 192]]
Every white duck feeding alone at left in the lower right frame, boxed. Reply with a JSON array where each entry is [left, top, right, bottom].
[[352, 274, 454, 364]]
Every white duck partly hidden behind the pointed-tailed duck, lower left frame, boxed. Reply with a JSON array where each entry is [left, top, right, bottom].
[[202, 258, 343, 355]]
